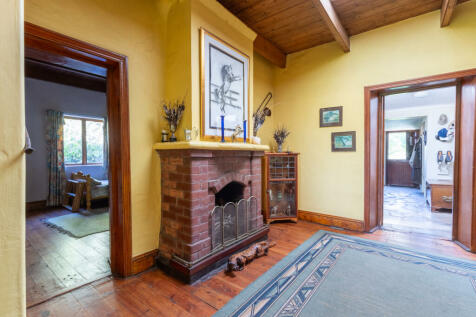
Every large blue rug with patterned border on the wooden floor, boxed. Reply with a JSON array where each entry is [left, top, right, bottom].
[[215, 231, 476, 317]]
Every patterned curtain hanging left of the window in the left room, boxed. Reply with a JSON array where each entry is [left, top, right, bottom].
[[46, 110, 65, 206]]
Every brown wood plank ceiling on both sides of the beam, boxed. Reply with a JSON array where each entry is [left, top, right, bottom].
[[218, 0, 467, 59]]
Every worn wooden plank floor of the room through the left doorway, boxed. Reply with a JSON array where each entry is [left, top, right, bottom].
[[25, 209, 110, 306]]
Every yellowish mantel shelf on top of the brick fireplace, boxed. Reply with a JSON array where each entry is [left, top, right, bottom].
[[153, 141, 269, 151]]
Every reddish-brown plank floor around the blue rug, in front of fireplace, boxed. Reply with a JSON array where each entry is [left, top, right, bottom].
[[27, 221, 476, 317]]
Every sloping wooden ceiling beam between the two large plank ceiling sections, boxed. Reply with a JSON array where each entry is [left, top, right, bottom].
[[312, 0, 350, 52]]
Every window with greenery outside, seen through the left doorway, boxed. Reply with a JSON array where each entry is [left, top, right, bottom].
[[63, 116, 104, 165]]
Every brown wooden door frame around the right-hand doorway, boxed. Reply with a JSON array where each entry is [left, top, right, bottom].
[[364, 68, 476, 252]]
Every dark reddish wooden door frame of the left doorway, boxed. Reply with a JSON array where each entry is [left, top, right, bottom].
[[24, 22, 132, 277]]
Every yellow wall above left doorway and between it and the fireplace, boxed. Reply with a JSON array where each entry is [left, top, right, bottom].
[[25, 0, 168, 255]]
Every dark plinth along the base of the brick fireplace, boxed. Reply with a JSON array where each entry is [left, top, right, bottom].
[[157, 225, 269, 284]]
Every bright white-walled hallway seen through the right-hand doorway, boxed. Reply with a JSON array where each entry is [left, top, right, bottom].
[[382, 85, 456, 240]]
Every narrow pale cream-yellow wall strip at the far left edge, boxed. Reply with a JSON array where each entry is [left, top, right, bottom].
[[0, 0, 25, 317]]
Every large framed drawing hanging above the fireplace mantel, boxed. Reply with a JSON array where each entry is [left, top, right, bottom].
[[200, 28, 251, 141]]
